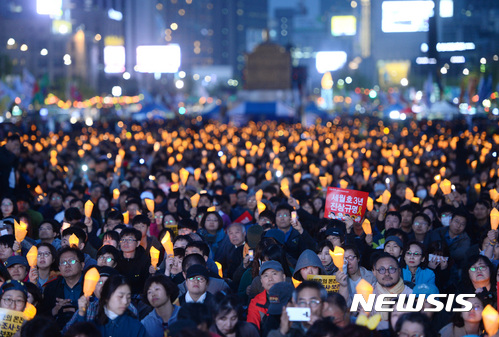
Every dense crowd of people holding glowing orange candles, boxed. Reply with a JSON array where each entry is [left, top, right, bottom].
[[0, 116, 499, 337]]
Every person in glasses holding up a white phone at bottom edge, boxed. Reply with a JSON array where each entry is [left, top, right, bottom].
[[268, 281, 327, 337]]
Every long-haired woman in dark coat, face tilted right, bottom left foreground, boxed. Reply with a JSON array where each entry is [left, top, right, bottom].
[[72, 275, 148, 337]]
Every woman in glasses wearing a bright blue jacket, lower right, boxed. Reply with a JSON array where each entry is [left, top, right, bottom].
[[401, 241, 435, 286]]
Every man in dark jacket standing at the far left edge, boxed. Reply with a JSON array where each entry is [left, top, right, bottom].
[[0, 135, 21, 197]]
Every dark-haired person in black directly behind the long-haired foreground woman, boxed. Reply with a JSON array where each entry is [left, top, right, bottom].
[[116, 228, 151, 295]]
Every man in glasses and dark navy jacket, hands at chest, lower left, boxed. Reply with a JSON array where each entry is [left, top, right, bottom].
[[40, 247, 85, 329]]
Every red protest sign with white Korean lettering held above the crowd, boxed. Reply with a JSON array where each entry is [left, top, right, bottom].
[[324, 187, 369, 222]]
